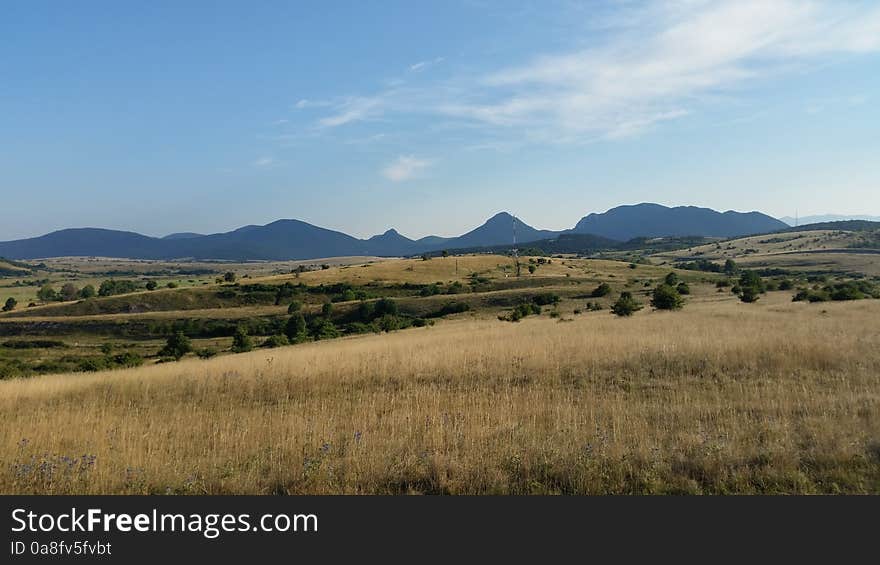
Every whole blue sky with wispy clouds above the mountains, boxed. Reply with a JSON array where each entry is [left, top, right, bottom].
[[0, 0, 880, 240]]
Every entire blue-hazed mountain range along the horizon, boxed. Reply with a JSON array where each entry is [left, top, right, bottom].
[[0, 203, 788, 261]]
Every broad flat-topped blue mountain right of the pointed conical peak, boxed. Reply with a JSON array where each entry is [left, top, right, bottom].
[[571, 203, 788, 241]]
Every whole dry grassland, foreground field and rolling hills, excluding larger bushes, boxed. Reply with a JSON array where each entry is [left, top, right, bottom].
[[0, 247, 880, 494]]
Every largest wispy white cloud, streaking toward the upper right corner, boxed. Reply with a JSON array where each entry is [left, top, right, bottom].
[[308, 0, 880, 141]]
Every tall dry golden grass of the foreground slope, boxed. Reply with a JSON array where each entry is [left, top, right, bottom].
[[0, 294, 880, 493]]
